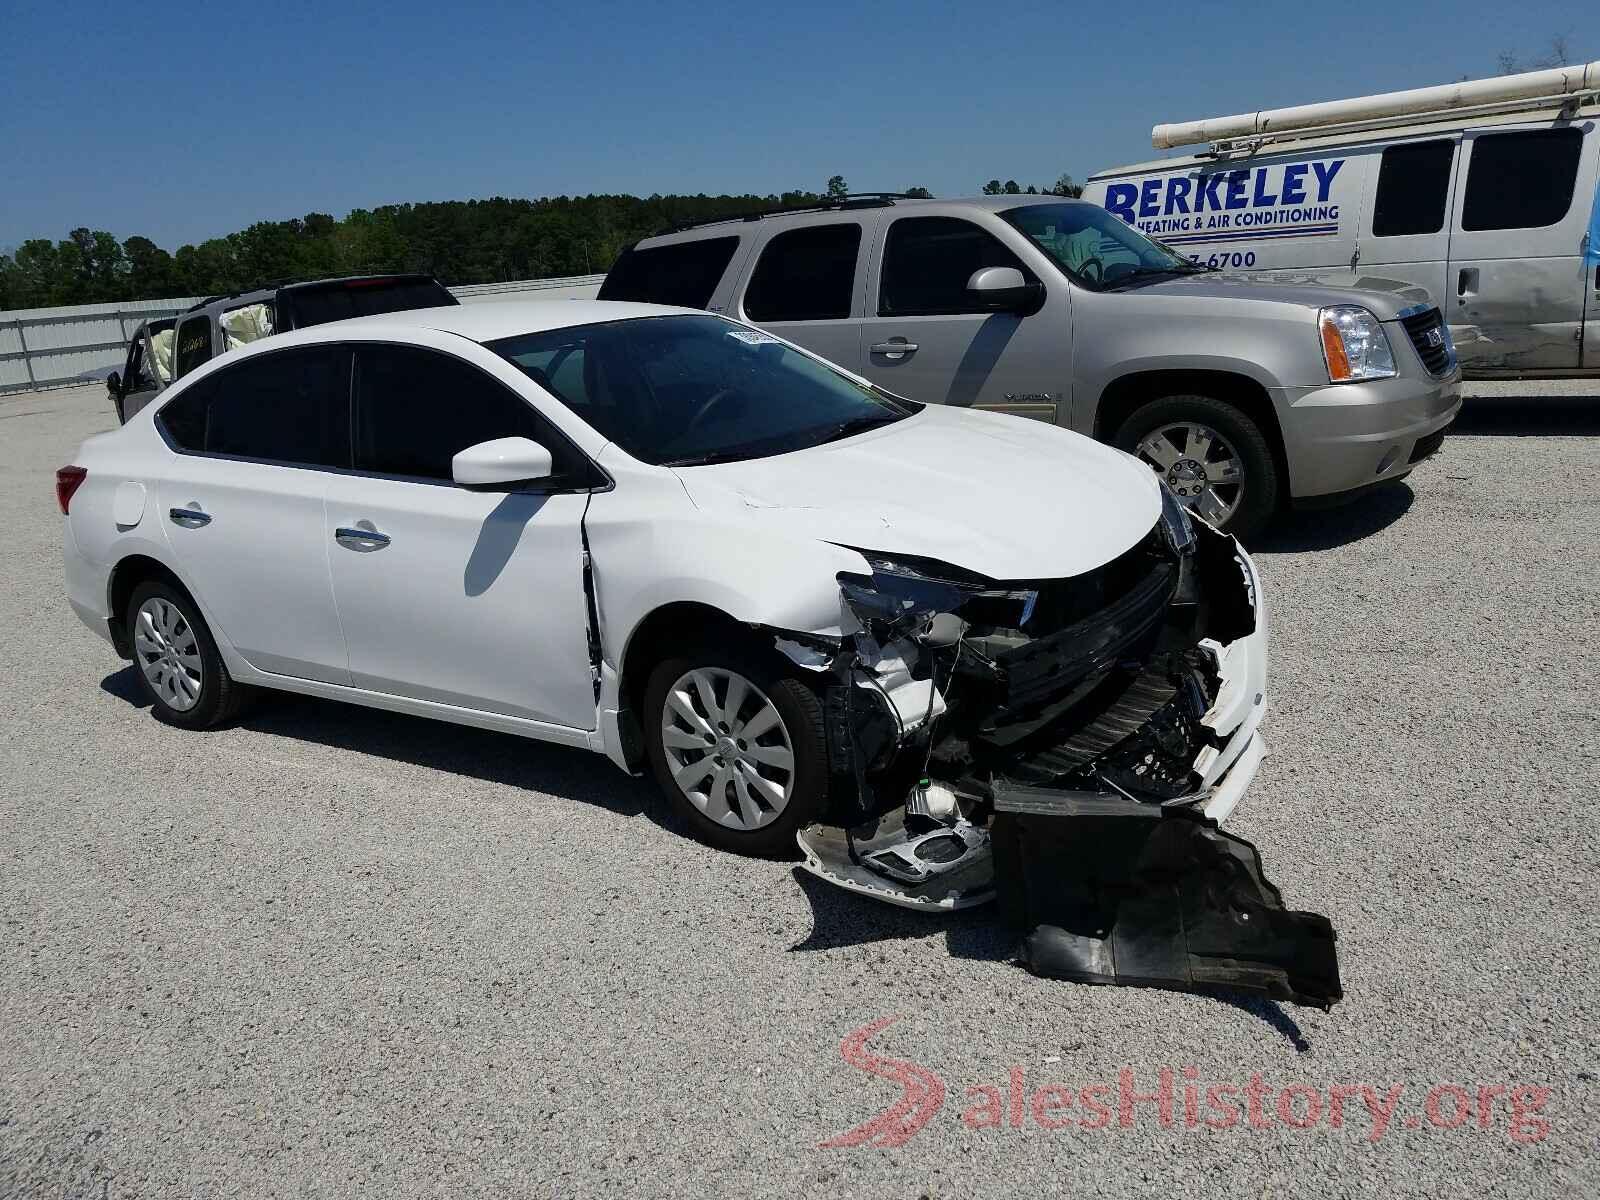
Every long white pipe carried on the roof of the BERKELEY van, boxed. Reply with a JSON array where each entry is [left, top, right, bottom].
[[1150, 61, 1600, 154]]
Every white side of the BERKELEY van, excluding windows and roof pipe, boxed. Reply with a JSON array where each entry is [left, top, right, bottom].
[[1083, 112, 1600, 378]]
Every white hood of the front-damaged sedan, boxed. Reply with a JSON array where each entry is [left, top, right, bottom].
[[675, 405, 1162, 579]]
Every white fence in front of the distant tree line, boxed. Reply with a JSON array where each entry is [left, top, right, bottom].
[[0, 275, 605, 394]]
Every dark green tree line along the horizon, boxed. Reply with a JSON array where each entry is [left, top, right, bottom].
[[0, 176, 1070, 309]]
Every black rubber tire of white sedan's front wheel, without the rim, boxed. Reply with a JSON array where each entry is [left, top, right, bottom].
[[642, 645, 829, 858]]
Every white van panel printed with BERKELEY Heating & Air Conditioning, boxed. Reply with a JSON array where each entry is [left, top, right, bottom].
[[1083, 146, 1379, 270]]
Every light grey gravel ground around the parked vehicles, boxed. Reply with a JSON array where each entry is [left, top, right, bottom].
[[0, 384, 1600, 1198]]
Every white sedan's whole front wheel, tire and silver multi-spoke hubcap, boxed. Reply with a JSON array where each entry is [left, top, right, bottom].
[[643, 650, 827, 854]]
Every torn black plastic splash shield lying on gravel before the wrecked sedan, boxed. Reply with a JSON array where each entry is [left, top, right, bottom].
[[990, 784, 1344, 1010]]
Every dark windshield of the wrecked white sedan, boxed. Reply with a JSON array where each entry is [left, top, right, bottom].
[[488, 315, 920, 466]]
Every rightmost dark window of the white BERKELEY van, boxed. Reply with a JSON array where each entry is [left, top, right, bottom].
[[1461, 128, 1584, 230]]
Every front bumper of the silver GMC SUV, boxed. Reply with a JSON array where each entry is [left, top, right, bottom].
[[1274, 368, 1461, 499]]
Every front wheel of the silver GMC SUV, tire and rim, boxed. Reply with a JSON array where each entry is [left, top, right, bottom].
[[1112, 395, 1283, 538]]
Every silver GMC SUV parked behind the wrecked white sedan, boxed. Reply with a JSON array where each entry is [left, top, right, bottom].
[[600, 194, 1461, 534]]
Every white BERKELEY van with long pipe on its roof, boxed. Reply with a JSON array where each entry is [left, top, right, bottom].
[[1083, 62, 1600, 378]]
